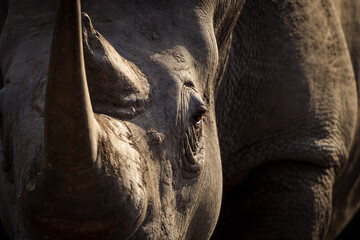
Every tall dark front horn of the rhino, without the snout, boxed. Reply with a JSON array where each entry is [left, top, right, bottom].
[[44, 0, 99, 171]]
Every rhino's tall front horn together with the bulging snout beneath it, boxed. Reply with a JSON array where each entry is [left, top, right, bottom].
[[18, 0, 147, 240]]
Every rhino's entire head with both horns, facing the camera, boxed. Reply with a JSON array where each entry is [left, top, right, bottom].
[[0, 0, 243, 239]]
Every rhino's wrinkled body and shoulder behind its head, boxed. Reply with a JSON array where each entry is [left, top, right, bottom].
[[212, 0, 360, 239]]
